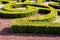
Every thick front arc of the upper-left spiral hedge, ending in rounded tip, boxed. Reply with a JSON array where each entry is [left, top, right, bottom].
[[0, 7, 38, 18]]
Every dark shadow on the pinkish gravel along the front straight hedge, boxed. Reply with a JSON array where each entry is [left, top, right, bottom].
[[0, 27, 60, 37]]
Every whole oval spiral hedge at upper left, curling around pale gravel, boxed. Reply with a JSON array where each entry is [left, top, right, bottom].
[[0, 3, 52, 18]]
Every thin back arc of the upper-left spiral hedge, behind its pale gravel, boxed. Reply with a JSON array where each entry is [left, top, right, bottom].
[[3, 2, 49, 11]]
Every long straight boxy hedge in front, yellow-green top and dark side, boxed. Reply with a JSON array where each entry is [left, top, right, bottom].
[[11, 19, 60, 34]]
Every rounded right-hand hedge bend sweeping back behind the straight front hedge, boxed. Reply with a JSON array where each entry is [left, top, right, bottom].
[[27, 7, 58, 22]]
